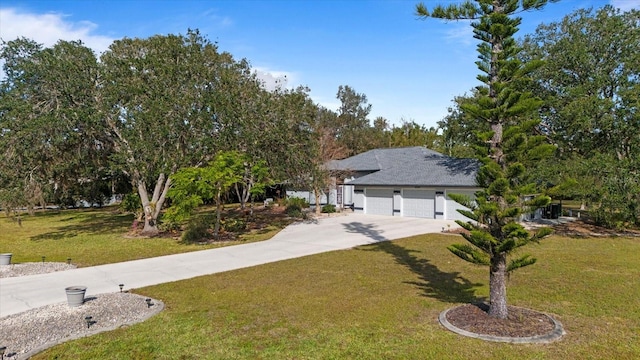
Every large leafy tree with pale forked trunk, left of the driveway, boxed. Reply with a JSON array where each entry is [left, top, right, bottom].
[[100, 31, 250, 234]]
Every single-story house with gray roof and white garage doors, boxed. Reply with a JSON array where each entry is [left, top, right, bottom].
[[287, 146, 479, 220]]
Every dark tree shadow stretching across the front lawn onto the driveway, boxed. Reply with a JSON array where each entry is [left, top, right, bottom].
[[344, 222, 485, 303]]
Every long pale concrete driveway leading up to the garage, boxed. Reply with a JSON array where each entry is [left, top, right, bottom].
[[0, 214, 458, 316]]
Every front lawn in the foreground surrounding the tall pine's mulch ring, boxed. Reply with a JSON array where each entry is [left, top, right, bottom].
[[21, 224, 640, 359]]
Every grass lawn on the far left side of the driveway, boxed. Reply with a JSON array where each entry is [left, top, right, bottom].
[[0, 207, 286, 267]]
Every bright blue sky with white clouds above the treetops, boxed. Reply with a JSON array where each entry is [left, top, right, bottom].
[[0, 0, 640, 127]]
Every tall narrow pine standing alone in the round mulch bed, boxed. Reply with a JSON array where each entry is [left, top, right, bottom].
[[416, 0, 554, 319]]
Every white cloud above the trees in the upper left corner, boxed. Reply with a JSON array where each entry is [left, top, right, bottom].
[[0, 8, 114, 54]]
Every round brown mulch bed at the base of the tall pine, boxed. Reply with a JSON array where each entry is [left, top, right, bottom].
[[447, 304, 555, 337]]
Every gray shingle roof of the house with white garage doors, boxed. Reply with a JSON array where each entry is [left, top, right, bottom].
[[329, 146, 479, 187]]
